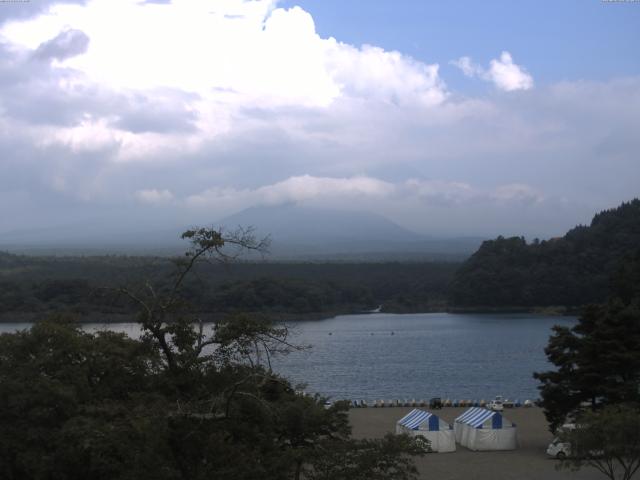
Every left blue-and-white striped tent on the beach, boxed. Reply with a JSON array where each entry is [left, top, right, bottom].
[[396, 408, 456, 452]]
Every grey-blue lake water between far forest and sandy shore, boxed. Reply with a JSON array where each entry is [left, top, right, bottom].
[[0, 313, 576, 401]]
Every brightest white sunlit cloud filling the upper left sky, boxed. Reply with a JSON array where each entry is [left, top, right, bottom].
[[0, 0, 447, 161]]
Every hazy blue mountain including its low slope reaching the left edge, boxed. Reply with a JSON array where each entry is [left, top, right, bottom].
[[0, 205, 482, 261]]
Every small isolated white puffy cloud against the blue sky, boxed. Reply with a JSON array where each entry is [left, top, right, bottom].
[[449, 51, 533, 92]]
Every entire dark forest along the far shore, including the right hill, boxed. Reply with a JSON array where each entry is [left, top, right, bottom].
[[5, 199, 640, 322]]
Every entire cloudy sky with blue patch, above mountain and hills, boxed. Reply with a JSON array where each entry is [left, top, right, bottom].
[[0, 0, 640, 238]]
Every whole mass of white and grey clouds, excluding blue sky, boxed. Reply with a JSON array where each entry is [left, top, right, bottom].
[[0, 0, 640, 238]]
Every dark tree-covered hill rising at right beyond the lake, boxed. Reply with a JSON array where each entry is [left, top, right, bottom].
[[449, 199, 640, 307]]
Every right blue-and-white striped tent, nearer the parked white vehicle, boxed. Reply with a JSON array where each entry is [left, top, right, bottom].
[[454, 407, 518, 450]]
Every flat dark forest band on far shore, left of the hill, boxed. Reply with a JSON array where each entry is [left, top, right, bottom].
[[0, 254, 459, 320]]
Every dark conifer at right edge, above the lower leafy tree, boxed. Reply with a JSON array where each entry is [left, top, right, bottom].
[[534, 251, 640, 430]]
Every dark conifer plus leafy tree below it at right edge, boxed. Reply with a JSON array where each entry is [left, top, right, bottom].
[[534, 251, 640, 480]]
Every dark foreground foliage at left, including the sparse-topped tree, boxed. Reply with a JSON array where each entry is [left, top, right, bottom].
[[0, 229, 419, 480]]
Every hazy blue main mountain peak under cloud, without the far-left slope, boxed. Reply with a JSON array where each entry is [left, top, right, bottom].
[[219, 205, 481, 260]]
